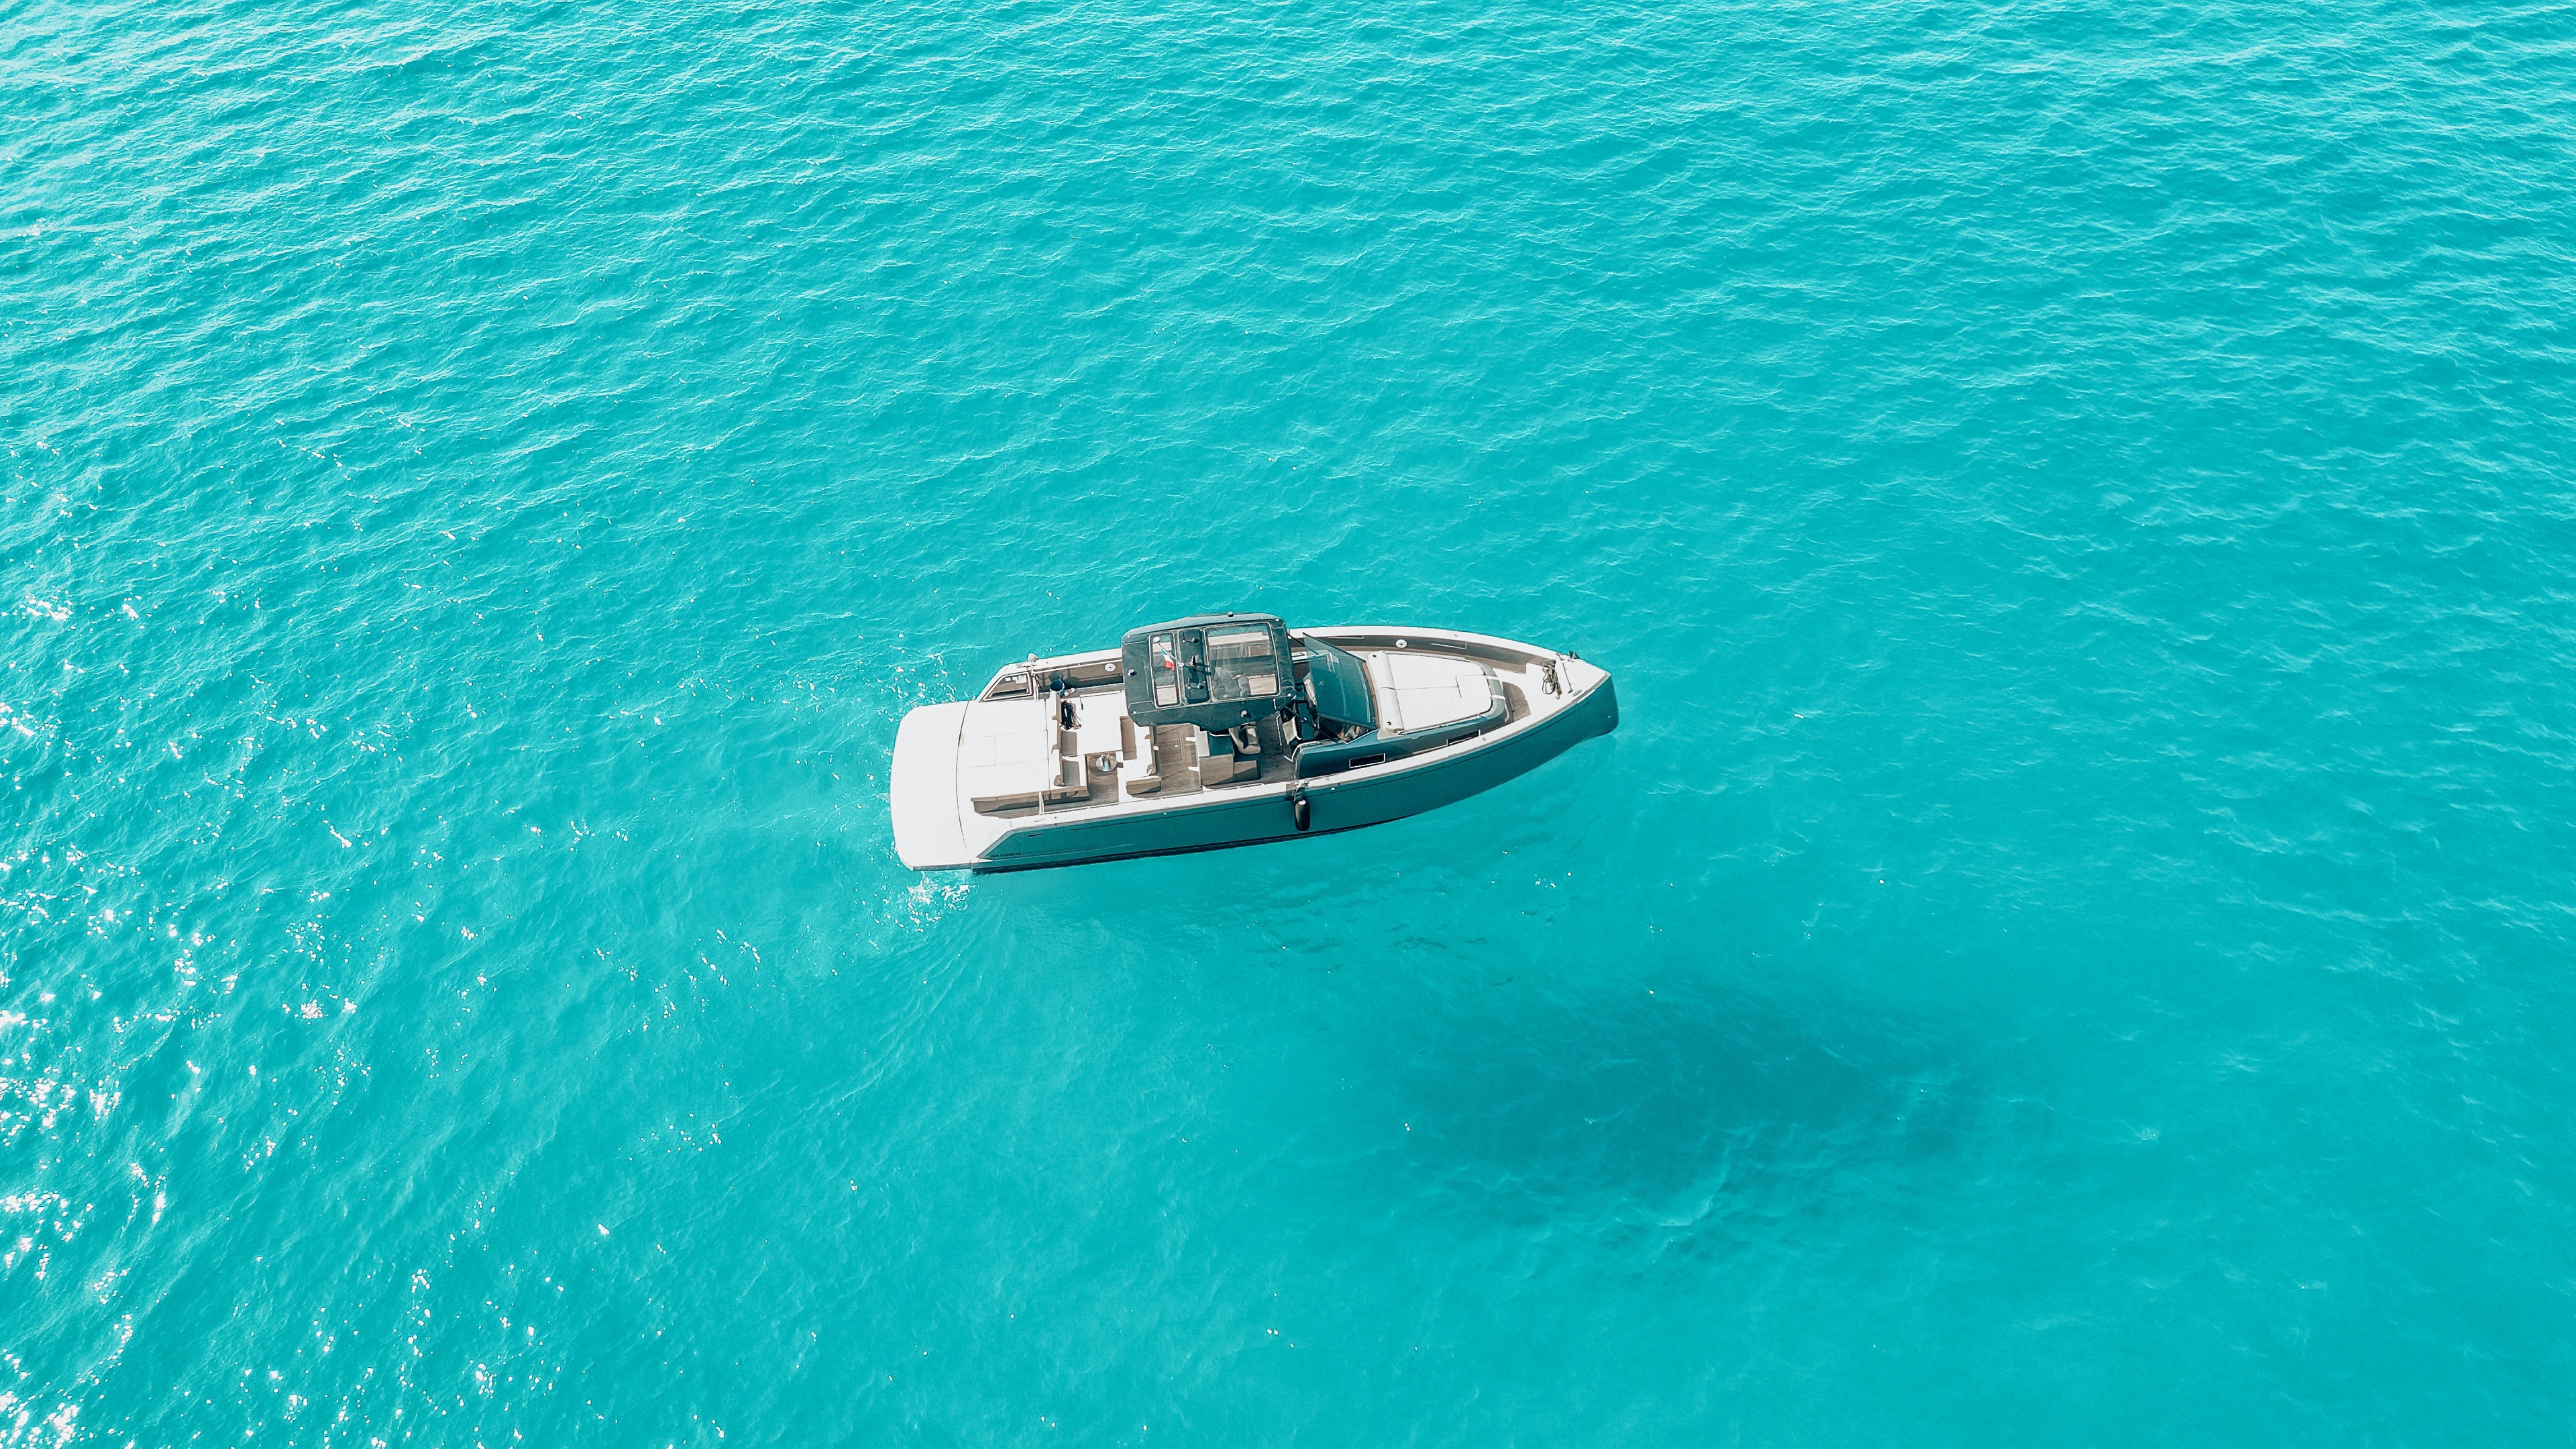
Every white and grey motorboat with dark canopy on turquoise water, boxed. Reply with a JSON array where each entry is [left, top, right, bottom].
[[892, 603, 1618, 871]]
